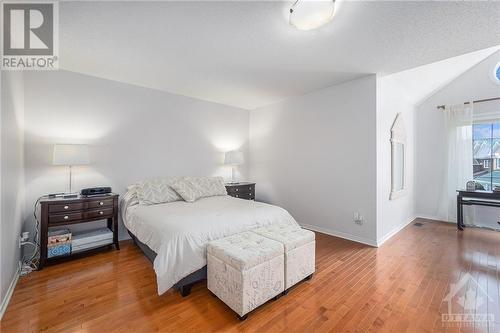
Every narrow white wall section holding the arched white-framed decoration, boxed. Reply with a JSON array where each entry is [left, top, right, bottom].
[[377, 74, 415, 244]]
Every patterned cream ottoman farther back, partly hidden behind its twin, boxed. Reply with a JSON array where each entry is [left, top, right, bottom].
[[252, 225, 316, 290]]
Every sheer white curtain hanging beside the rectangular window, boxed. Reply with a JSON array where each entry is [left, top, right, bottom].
[[440, 103, 473, 222]]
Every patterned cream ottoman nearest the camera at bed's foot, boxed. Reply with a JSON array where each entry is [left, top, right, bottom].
[[207, 231, 285, 320]]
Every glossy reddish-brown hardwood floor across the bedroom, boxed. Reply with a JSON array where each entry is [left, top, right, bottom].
[[1, 219, 500, 332]]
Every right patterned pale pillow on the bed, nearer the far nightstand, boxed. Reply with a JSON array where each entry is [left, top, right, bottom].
[[172, 177, 227, 202]]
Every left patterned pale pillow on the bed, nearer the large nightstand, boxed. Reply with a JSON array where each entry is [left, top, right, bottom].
[[137, 178, 182, 205]]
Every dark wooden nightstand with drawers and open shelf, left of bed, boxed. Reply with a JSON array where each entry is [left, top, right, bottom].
[[38, 194, 120, 270]]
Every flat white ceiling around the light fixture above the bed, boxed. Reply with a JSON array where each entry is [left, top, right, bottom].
[[59, 1, 500, 109]]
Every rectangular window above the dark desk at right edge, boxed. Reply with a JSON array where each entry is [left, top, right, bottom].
[[472, 122, 500, 190]]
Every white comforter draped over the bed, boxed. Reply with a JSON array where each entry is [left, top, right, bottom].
[[123, 196, 297, 295]]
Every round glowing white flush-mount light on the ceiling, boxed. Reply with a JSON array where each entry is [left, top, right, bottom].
[[289, 0, 335, 31]]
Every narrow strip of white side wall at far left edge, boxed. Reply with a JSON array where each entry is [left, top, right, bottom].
[[0, 72, 24, 316]]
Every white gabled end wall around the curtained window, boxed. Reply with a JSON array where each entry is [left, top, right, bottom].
[[416, 51, 500, 228]]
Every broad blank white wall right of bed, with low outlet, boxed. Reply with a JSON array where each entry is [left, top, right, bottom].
[[250, 75, 376, 245]]
